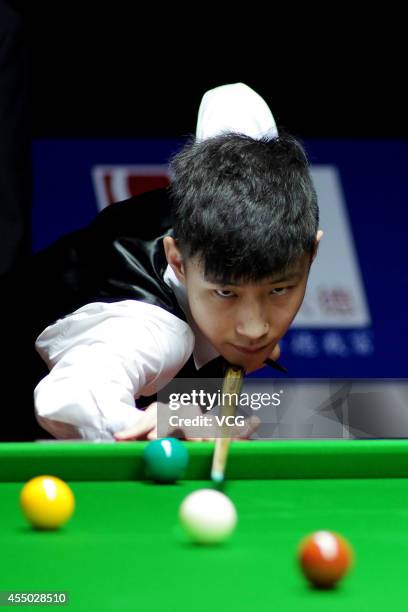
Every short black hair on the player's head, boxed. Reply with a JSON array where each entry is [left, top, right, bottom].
[[170, 133, 319, 284]]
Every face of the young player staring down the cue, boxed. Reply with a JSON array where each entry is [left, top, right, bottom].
[[163, 237, 311, 371]]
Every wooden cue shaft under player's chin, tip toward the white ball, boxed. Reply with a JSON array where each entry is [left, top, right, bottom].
[[211, 365, 245, 481]]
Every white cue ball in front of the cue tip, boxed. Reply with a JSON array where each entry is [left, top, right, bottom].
[[179, 489, 237, 544]]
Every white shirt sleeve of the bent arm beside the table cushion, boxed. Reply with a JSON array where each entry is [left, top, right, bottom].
[[34, 300, 194, 440]]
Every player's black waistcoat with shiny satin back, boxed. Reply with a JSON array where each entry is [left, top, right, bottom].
[[31, 189, 224, 394]]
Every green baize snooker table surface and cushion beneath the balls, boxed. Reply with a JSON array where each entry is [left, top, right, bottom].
[[0, 440, 408, 612]]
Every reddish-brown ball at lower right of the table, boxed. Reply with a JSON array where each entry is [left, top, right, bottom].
[[298, 531, 354, 588]]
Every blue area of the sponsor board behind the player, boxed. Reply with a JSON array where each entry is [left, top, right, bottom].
[[33, 140, 408, 378]]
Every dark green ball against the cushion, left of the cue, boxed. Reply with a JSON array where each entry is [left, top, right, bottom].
[[143, 438, 188, 483]]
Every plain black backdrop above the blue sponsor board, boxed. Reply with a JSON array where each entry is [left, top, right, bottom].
[[11, 0, 408, 138]]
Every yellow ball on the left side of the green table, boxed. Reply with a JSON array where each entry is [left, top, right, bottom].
[[20, 476, 75, 529]]
